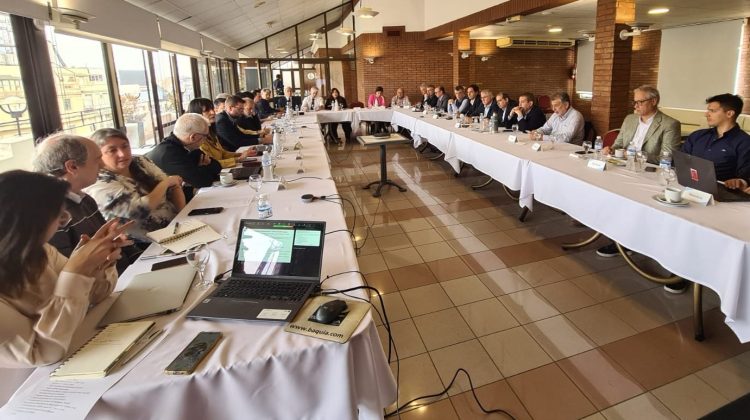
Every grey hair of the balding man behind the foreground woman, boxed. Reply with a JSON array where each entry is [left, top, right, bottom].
[[33, 133, 89, 176]]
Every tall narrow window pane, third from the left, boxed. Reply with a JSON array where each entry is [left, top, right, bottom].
[[112, 45, 158, 148]]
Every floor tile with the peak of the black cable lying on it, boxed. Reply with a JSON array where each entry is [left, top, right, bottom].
[[430, 339, 503, 395]]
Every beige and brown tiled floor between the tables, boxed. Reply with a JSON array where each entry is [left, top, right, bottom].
[[330, 144, 750, 420]]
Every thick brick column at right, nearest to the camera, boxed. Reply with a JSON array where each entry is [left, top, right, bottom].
[[591, 0, 635, 134]]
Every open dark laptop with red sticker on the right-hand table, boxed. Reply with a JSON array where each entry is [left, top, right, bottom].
[[674, 151, 750, 202]]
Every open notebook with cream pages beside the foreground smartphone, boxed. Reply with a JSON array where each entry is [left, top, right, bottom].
[[50, 321, 154, 379]]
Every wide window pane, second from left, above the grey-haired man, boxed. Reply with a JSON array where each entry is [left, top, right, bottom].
[[46, 26, 114, 136]]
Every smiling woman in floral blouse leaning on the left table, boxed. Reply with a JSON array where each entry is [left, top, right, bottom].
[[85, 128, 185, 243]]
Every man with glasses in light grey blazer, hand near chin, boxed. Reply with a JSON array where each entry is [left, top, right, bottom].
[[603, 85, 681, 164]]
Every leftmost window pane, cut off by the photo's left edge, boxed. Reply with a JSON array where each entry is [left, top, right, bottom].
[[0, 13, 34, 172]]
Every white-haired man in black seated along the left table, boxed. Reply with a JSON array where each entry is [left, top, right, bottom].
[[146, 113, 221, 200]]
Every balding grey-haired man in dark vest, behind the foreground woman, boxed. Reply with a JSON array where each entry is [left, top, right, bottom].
[[34, 133, 143, 274]]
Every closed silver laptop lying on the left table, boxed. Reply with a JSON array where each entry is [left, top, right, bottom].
[[99, 264, 195, 327]]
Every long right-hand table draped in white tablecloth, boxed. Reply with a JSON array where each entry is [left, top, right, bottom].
[[314, 108, 750, 342]]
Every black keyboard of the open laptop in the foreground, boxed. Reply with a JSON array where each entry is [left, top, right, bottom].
[[214, 279, 310, 302]]
